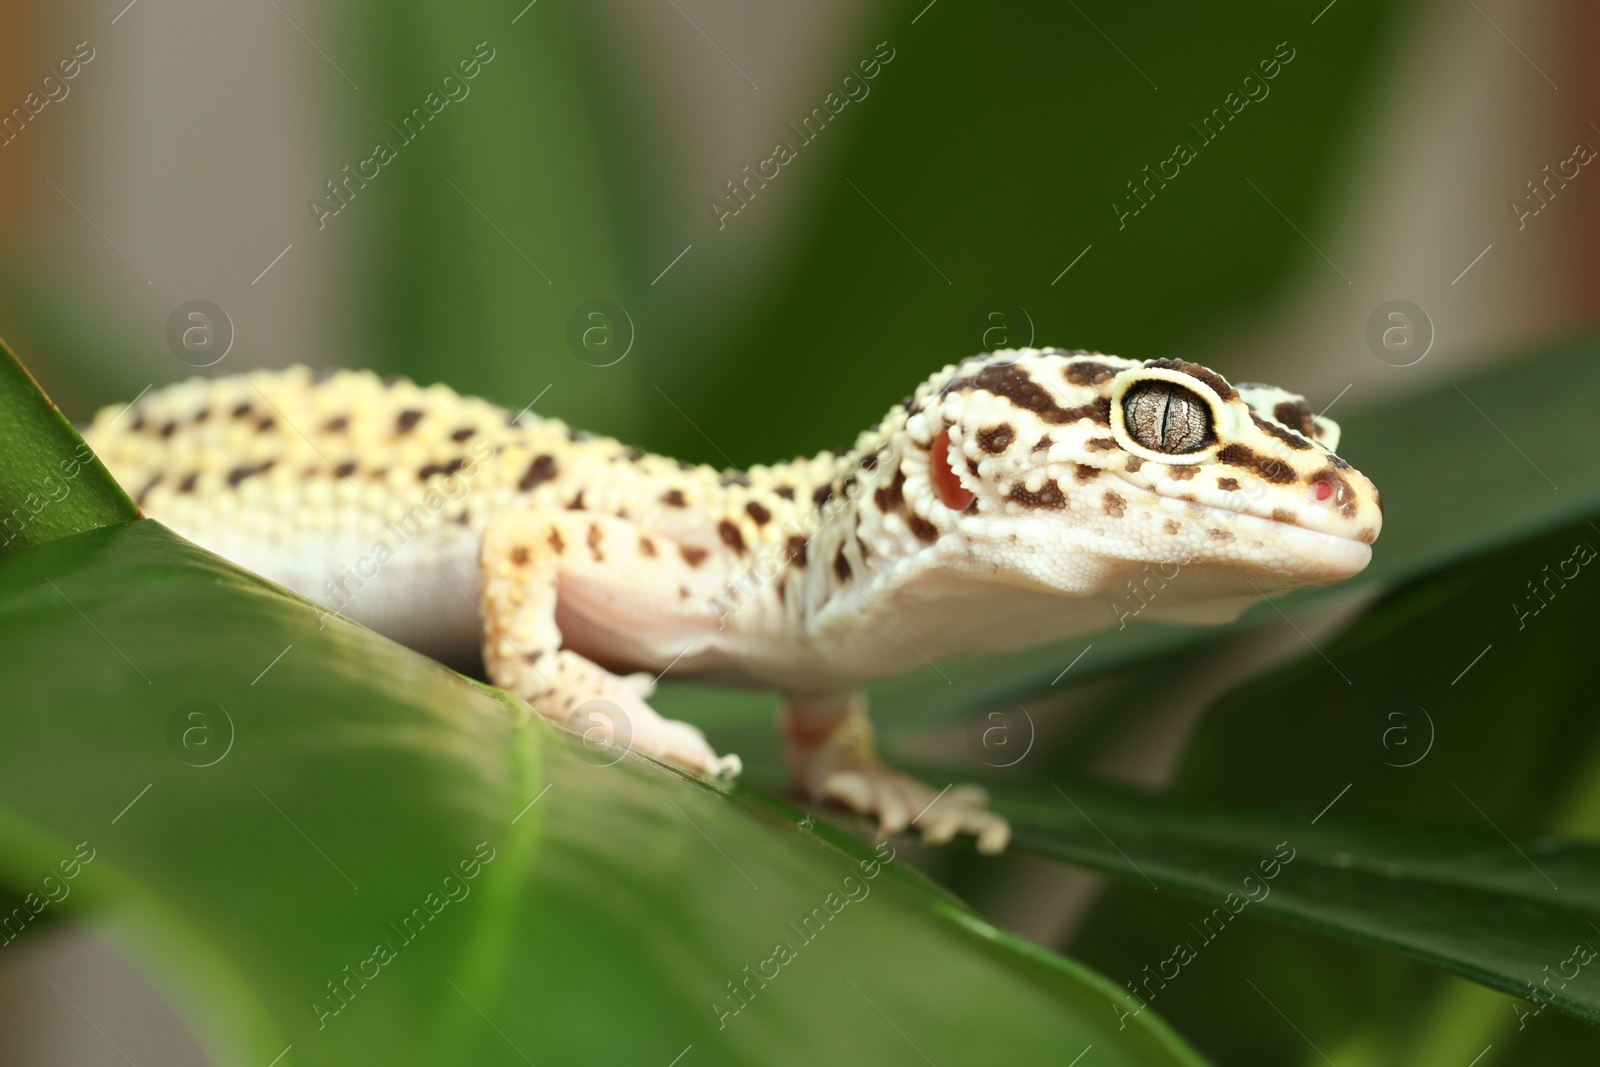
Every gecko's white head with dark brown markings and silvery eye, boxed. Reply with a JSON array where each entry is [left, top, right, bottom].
[[902, 349, 1382, 600]]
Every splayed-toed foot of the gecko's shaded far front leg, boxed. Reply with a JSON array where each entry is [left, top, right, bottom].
[[816, 763, 1011, 856]]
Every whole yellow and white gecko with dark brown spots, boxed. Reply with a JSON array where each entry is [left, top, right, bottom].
[[85, 349, 1382, 853]]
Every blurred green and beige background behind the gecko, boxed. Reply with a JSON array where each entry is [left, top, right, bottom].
[[0, 0, 1600, 1064]]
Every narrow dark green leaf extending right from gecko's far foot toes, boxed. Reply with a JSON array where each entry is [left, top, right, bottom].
[[1000, 782, 1600, 1022]]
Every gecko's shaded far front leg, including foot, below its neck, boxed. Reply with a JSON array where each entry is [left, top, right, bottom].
[[782, 693, 1011, 856]]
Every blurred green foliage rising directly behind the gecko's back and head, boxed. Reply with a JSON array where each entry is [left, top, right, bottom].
[[370, 0, 1387, 466]]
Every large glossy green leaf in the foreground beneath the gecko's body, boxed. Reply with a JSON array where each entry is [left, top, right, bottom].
[[0, 522, 1198, 1064]]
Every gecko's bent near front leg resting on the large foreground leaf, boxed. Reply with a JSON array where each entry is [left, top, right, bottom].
[[478, 510, 741, 776]]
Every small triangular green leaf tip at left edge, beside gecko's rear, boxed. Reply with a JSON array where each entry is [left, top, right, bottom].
[[0, 341, 139, 552]]
